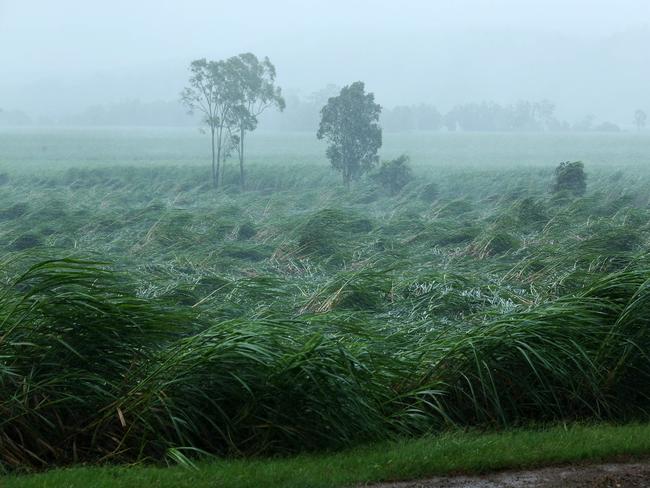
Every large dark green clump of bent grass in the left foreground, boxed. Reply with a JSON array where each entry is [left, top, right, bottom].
[[0, 260, 192, 467]]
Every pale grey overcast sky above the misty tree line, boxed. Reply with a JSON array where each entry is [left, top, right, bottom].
[[0, 0, 650, 124]]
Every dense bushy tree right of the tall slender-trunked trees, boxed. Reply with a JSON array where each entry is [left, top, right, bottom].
[[317, 81, 382, 188]]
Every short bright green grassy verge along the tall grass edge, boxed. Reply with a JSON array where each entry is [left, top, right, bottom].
[[5, 424, 650, 488]]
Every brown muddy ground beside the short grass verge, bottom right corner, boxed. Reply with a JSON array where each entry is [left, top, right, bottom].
[[364, 460, 650, 488]]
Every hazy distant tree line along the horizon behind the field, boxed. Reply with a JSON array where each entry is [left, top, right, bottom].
[[0, 92, 647, 132]]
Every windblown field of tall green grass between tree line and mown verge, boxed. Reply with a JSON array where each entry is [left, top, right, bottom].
[[0, 129, 650, 476]]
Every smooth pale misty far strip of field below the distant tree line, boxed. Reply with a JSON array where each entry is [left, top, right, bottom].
[[0, 128, 650, 173]]
